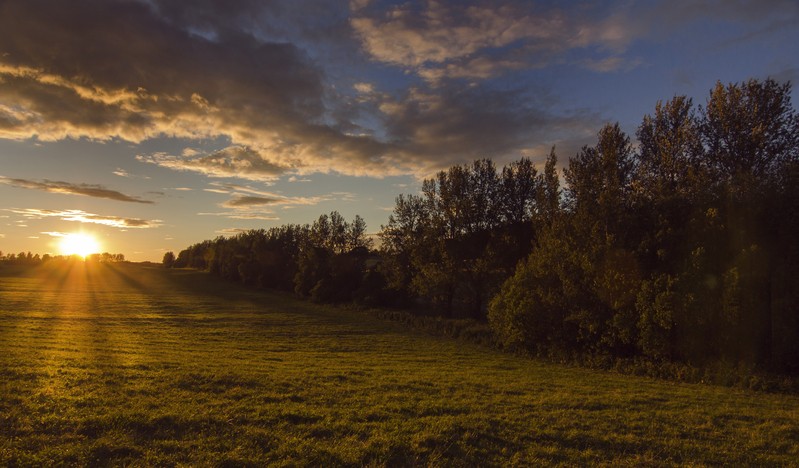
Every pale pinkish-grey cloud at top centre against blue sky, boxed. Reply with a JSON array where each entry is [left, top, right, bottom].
[[351, 1, 635, 81]]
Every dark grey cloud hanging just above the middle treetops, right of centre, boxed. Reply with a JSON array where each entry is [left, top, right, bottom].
[[379, 86, 603, 177]]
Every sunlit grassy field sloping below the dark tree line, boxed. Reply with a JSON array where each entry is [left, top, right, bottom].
[[0, 263, 799, 466]]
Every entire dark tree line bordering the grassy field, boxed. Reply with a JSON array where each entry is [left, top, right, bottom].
[[164, 79, 799, 372]]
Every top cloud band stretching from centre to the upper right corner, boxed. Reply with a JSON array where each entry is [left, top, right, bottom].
[[350, 0, 799, 83]]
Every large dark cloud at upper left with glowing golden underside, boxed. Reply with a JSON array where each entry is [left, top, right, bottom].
[[0, 0, 390, 179]]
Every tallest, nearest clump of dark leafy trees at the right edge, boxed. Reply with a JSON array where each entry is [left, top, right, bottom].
[[489, 80, 799, 371]]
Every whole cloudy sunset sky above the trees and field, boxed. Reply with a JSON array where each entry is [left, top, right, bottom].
[[0, 0, 799, 262]]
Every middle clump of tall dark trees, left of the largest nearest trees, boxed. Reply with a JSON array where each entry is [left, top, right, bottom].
[[379, 157, 558, 319]]
